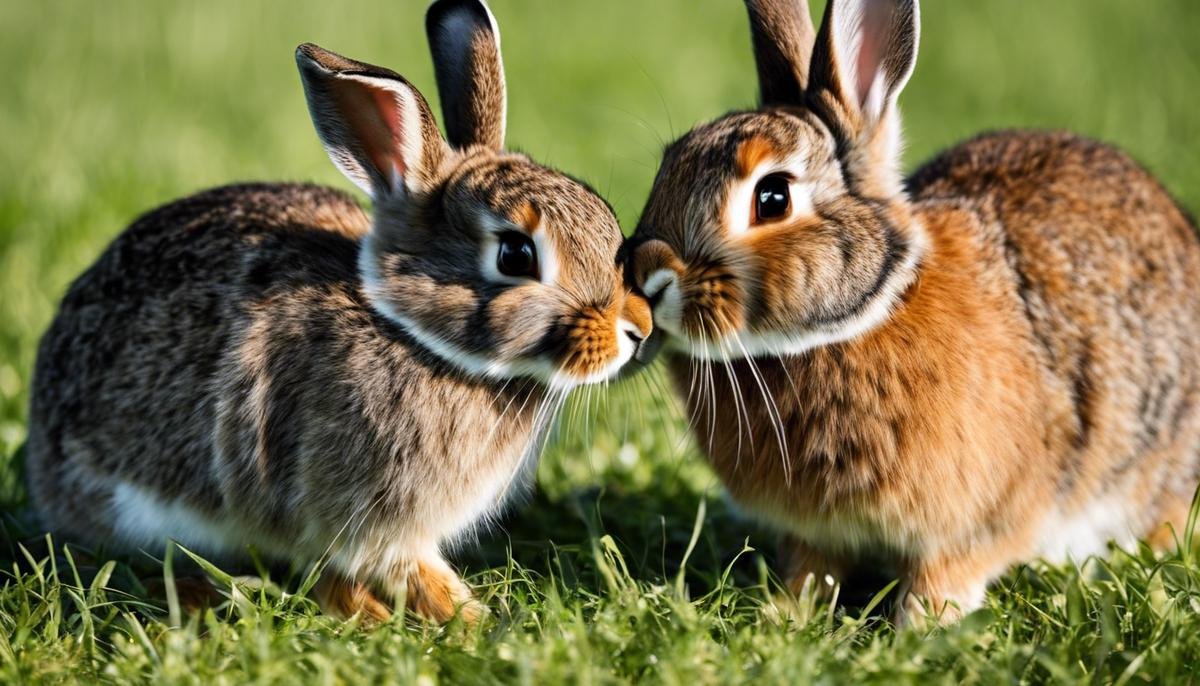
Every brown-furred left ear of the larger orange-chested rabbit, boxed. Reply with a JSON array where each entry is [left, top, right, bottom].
[[745, 0, 816, 107]]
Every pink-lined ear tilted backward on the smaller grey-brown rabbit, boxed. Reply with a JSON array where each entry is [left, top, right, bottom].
[[296, 43, 448, 201]]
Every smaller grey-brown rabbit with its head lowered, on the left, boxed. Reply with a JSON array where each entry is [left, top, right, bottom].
[[28, 0, 650, 621]]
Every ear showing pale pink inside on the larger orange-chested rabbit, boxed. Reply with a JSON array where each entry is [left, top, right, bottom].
[[809, 0, 920, 134]]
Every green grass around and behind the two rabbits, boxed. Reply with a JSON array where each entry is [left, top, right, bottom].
[[0, 0, 1200, 684]]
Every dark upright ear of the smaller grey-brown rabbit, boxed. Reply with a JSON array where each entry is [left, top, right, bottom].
[[425, 0, 506, 150]]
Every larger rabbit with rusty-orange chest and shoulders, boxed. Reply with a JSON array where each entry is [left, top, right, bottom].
[[628, 0, 1200, 624]]
